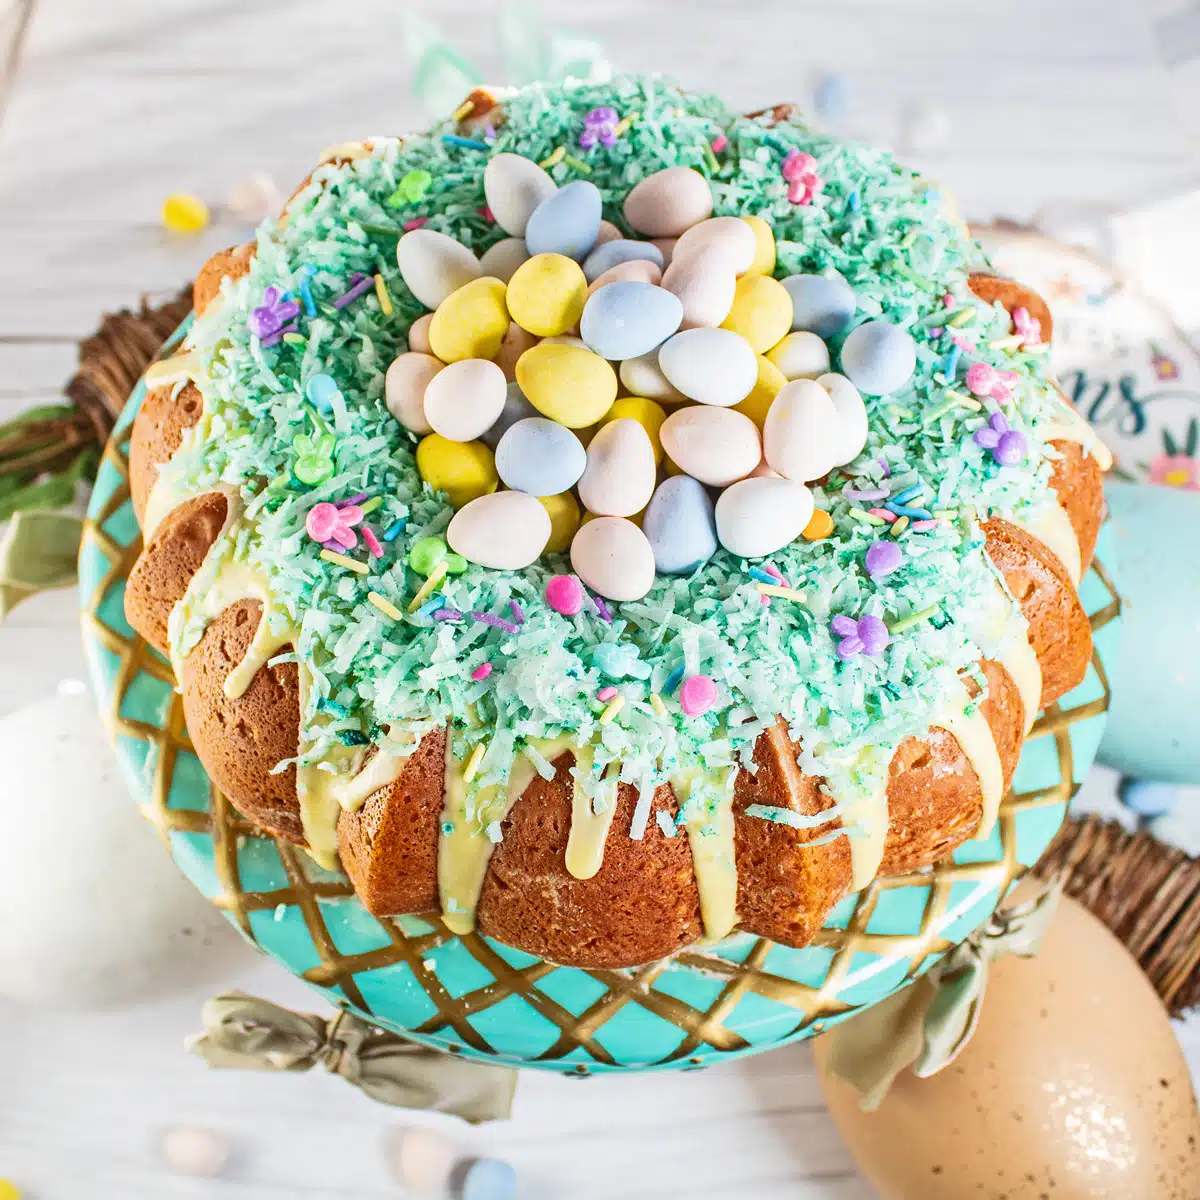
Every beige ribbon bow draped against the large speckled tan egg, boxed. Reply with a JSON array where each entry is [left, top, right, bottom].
[[826, 881, 1062, 1112]]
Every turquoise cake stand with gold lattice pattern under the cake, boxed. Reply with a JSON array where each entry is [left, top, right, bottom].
[[79, 331, 1120, 1075]]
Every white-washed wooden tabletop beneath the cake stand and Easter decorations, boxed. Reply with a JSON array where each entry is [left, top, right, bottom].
[[0, 0, 1200, 1200]]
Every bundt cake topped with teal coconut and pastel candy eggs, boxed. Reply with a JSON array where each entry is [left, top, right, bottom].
[[126, 77, 1108, 967]]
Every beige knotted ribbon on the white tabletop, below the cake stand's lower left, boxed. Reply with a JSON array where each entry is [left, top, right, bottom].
[[187, 991, 517, 1124]]
